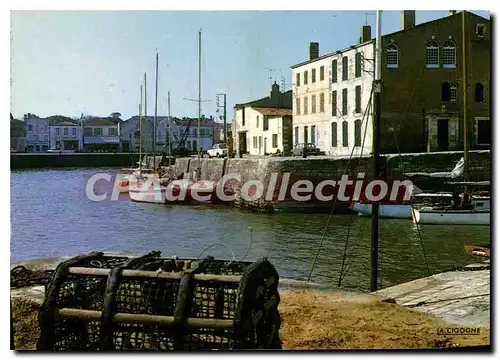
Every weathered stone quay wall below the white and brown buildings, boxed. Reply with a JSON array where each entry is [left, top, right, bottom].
[[170, 151, 491, 213]]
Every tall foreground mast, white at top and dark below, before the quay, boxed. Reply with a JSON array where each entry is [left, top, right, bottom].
[[370, 10, 382, 291]]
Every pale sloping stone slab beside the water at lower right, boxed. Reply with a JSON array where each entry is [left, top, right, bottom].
[[371, 270, 490, 328]]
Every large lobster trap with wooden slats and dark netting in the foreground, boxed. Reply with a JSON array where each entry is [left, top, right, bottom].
[[37, 252, 281, 351]]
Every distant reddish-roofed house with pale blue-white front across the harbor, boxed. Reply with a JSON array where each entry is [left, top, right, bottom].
[[83, 119, 120, 151]]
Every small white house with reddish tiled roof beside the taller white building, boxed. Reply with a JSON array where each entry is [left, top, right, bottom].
[[231, 83, 292, 155]]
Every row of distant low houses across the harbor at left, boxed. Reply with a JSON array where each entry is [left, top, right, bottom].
[[11, 114, 229, 152]]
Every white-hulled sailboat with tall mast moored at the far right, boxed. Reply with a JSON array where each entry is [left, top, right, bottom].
[[412, 11, 490, 225]]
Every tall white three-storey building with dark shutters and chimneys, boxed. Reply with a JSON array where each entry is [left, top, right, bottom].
[[292, 29, 374, 156]]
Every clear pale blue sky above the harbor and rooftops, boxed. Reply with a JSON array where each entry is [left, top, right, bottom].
[[11, 11, 489, 121]]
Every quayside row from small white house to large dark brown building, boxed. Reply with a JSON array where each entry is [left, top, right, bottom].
[[232, 11, 491, 156]]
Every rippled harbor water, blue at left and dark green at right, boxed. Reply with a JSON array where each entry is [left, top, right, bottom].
[[11, 168, 490, 291]]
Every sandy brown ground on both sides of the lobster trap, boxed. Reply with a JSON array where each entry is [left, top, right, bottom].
[[12, 290, 490, 350]]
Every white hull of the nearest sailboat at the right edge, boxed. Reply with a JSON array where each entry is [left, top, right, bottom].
[[412, 209, 490, 225]]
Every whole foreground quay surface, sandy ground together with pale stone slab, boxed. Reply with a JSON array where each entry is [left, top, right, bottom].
[[11, 252, 490, 349]]
